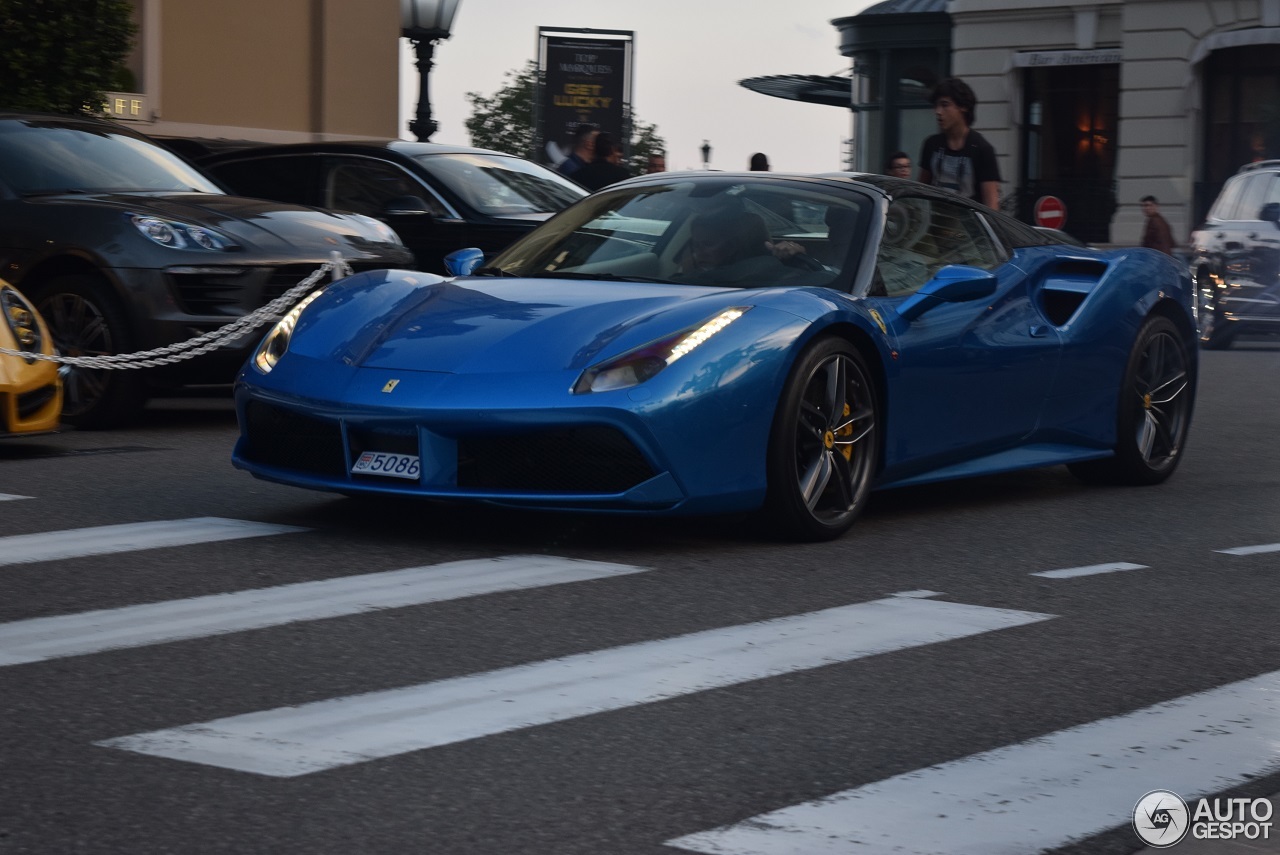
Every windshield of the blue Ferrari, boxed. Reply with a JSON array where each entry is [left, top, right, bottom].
[[484, 177, 873, 291]]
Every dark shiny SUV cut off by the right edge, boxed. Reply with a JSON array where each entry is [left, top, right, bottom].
[[1190, 160, 1280, 349]]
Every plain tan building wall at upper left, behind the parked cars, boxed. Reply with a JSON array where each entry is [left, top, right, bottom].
[[108, 0, 401, 142]]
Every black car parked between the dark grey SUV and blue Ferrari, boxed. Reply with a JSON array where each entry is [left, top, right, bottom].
[[196, 140, 586, 274]]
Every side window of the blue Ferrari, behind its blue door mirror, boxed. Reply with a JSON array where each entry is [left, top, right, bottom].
[[876, 196, 1001, 297]]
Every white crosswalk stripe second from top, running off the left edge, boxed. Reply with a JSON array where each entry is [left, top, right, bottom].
[[0, 555, 645, 667]]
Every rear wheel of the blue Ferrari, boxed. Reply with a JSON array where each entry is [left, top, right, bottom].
[[1069, 315, 1196, 485]]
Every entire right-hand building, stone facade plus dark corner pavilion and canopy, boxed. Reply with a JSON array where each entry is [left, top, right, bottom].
[[742, 0, 1280, 244]]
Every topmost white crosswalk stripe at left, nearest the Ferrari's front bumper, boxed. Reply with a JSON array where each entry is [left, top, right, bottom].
[[0, 517, 308, 566]]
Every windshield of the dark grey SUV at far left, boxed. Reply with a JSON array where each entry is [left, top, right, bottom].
[[0, 120, 221, 196]]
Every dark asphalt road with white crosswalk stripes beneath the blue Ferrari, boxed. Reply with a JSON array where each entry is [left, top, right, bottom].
[[0, 342, 1280, 855]]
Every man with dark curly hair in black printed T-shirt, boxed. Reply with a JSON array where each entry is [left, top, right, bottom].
[[918, 77, 1000, 209]]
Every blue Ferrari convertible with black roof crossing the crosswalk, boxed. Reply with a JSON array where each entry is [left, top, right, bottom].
[[234, 172, 1197, 540]]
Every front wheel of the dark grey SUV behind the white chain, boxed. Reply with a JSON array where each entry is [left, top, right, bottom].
[[31, 275, 147, 430]]
